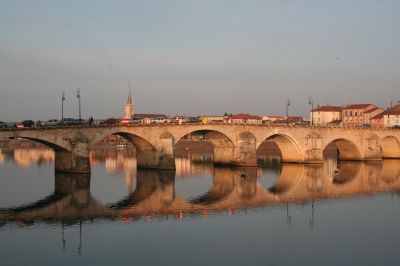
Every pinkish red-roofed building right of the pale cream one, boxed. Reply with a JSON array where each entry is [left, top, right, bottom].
[[342, 104, 383, 126]]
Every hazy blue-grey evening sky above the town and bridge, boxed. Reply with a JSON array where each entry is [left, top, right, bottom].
[[0, 0, 400, 121]]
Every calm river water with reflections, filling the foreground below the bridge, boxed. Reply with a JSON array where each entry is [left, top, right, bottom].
[[0, 149, 400, 266]]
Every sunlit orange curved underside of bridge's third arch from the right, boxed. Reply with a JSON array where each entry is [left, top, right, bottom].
[[257, 134, 303, 163]]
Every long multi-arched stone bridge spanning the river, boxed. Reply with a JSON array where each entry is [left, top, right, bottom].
[[0, 124, 400, 173]]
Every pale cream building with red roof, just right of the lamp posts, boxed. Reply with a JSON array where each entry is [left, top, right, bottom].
[[310, 105, 342, 126]]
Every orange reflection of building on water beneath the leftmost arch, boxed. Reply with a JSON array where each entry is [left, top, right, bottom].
[[14, 149, 54, 167]]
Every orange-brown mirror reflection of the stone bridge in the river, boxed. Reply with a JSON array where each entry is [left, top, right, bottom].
[[0, 160, 400, 224]]
